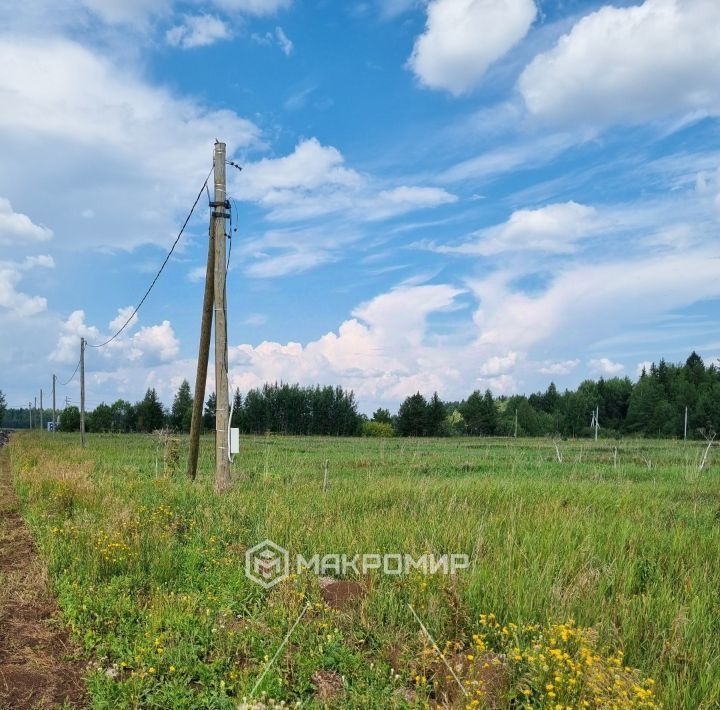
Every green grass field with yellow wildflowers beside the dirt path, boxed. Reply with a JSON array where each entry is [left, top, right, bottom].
[[10, 434, 720, 708]]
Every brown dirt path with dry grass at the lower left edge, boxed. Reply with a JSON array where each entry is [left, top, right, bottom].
[[0, 446, 85, 710]]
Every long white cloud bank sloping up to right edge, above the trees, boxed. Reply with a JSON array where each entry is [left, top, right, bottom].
[[469, 250, 720, 350]]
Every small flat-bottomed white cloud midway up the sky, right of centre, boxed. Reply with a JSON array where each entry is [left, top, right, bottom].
[[429, 202, 602, 256]]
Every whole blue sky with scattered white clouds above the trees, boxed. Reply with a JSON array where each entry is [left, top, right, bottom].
[[0, 0, 720, 411]]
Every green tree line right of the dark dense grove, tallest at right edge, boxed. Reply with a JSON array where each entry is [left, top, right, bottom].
[[388, 352, 720, 438]]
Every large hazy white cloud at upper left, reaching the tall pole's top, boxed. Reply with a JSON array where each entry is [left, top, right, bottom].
[[0, 37, 259, 249]]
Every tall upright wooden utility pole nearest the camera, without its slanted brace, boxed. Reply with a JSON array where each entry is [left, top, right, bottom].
[[212, 143, 230, 491]]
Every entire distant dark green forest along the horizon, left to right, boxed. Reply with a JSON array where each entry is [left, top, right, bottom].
[[0, 352, 720, 438]]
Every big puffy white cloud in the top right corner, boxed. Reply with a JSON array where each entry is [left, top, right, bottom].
[[519, 0, 720, 126]]
